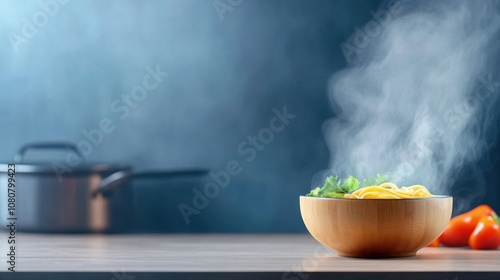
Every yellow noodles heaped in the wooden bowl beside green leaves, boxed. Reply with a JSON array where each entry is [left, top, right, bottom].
[[344, 183, 434, 199]]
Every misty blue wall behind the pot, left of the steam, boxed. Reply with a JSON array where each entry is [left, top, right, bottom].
[[0, 0, 390, 232]]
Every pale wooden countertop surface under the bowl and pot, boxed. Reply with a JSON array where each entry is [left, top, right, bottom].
[[0, 233, 500, 272]]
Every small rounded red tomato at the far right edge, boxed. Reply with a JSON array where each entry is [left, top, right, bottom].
[[469, 216, 500, 250]]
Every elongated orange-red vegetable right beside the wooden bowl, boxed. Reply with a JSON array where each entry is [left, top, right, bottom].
[[439, 204, 495, 247]]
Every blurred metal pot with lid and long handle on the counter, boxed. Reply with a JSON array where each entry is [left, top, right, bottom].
[[0, 143, 207, 233]]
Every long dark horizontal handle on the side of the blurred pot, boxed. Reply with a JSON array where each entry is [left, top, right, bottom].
[[92, 169, 209, 197]]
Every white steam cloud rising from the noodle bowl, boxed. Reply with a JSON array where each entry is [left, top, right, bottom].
[[320, 1, 500, 199]]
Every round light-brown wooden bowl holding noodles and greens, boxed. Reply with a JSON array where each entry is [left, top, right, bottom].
[[300, 196, 453, 258]]
